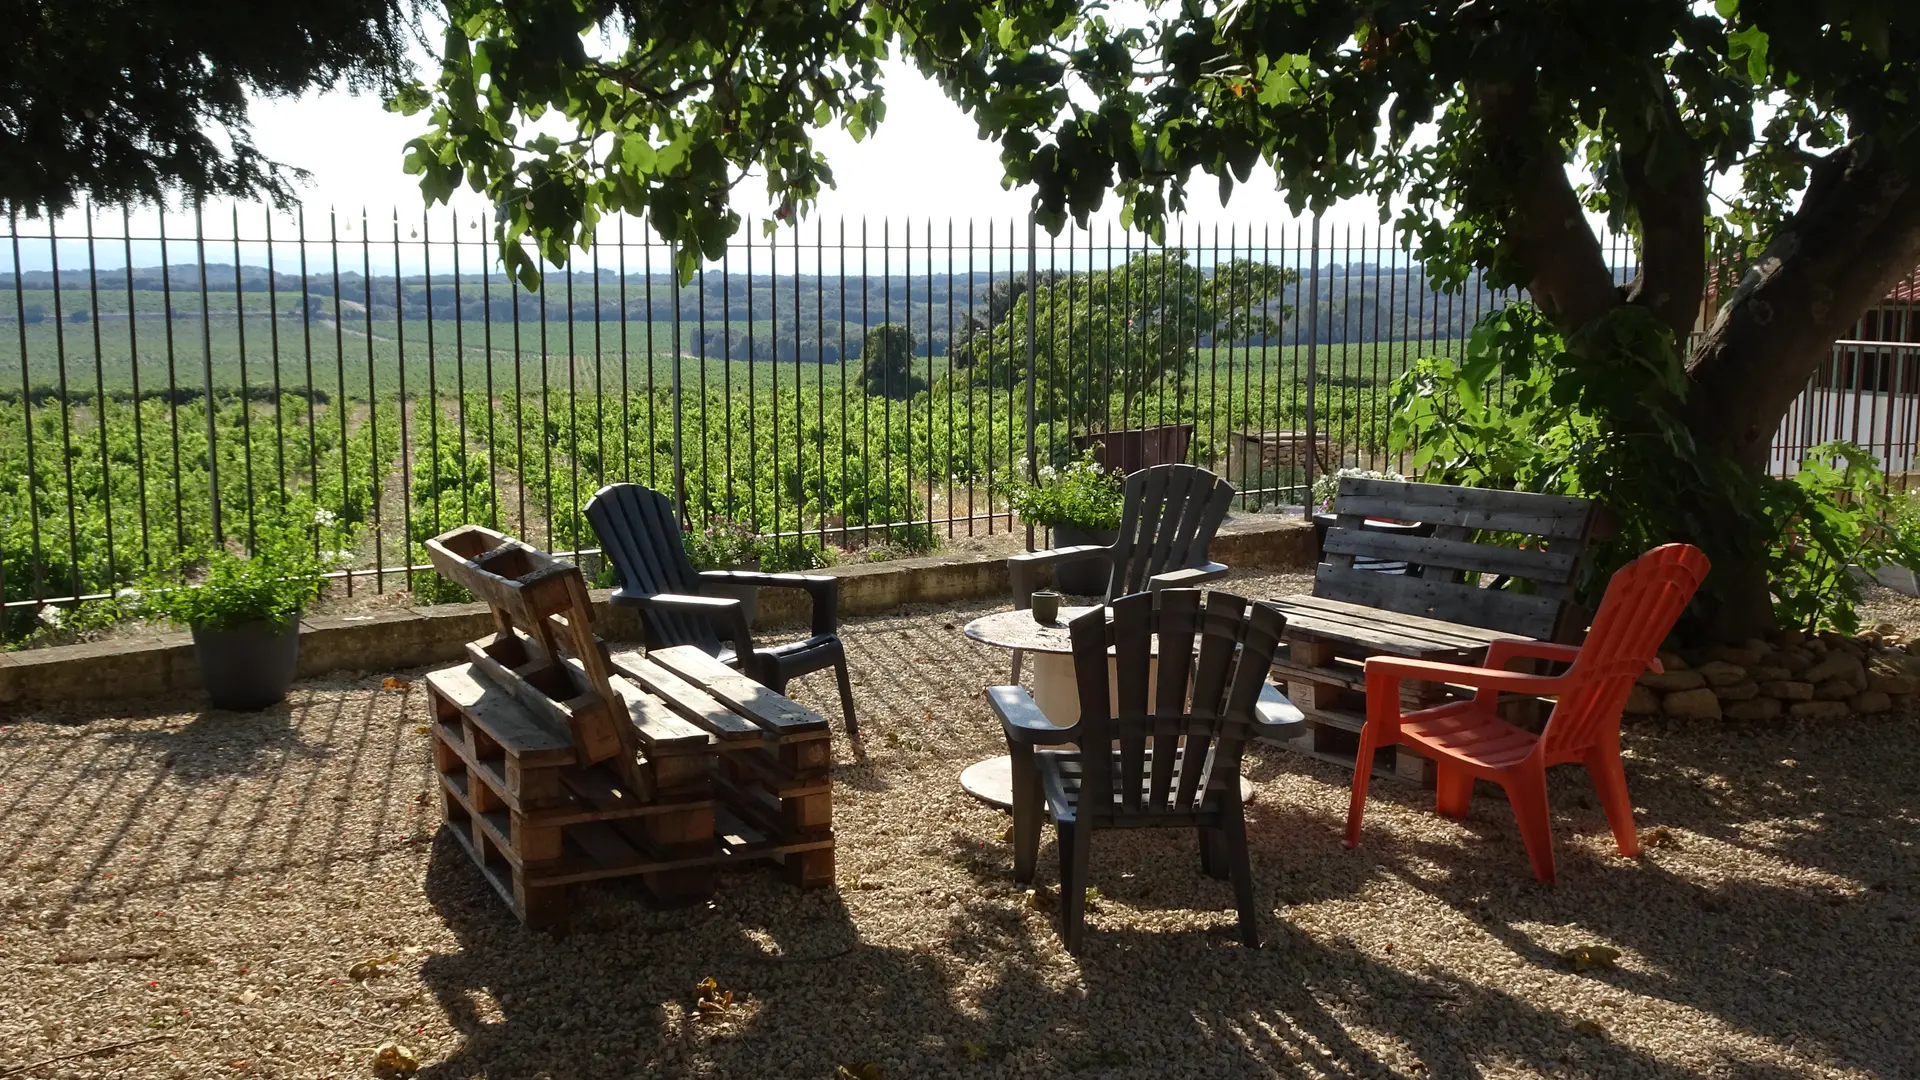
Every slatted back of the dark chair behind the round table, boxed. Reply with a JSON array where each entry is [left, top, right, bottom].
[[1106, 465, 1233, 603]]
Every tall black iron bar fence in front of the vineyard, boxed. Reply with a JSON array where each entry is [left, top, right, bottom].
[[0, 208, 1920, 636]]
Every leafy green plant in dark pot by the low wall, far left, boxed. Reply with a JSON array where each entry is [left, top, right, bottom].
[[138, 507, 348, 711]]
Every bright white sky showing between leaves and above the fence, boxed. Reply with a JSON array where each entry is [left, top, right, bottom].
[[0, 61, 1405, 273]]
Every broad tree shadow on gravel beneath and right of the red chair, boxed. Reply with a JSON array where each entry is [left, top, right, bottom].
[[1359, 732, 1920, 1078]]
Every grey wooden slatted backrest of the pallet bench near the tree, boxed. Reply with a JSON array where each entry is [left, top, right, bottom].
[[1313, 477, 1603, 640]]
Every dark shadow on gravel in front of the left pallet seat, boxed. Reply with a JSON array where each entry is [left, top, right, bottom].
[[420, 836, 990, 1078]]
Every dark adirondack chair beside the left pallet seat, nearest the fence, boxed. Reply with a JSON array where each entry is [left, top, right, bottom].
[[588, 484, 860, 738]]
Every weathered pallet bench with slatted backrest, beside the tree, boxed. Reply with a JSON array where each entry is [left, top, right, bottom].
[[1273, 477, 1605, 784]]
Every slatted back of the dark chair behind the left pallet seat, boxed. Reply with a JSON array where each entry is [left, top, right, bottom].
[[588, 484, 720, 653]]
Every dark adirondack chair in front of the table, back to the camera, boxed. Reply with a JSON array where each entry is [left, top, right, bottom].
[[987, 588, 1294, 953]]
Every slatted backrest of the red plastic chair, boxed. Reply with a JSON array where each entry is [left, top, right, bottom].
[[1540, 544, 1707, 759]]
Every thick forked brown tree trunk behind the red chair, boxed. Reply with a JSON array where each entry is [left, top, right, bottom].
[[1482, 130, 1920, 640]]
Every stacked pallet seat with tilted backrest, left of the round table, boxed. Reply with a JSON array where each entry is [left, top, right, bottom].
[[426, 527, 833, 926]]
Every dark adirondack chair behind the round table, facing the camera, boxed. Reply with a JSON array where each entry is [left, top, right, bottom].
[[1006, 465, 1233, 682]]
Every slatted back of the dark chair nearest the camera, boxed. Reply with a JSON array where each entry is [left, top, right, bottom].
[[1068, 588, 1286, 824]]
